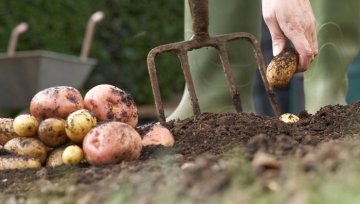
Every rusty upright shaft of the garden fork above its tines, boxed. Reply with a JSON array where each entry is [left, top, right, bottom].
[[189, 0, 209, 40]]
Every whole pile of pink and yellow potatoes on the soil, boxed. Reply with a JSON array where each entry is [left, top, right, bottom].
[[0, 84, 174, 170]]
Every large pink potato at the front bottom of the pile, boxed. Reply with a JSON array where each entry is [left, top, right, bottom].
[[82, 121, 142, 165]]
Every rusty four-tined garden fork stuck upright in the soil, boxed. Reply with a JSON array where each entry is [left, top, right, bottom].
[[147, 0, 280, 124]]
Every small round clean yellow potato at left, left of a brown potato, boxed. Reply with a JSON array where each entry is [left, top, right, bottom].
[[13, 114, 39, 137]]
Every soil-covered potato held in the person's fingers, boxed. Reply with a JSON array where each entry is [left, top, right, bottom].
[[266, 48, 299, 88]]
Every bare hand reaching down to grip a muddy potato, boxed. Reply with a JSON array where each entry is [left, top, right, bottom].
[[262, 0, 318, 72]]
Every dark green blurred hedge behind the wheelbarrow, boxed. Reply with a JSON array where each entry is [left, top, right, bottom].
[[0, 0, 184, 104]]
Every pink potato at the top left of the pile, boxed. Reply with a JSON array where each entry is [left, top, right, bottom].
[[30, 86, 84, 121]]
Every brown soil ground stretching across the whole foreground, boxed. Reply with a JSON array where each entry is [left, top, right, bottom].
[[0, 102, 360, 203]]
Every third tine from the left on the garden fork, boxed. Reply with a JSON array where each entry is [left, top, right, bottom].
[[217, 44, 242, 113]]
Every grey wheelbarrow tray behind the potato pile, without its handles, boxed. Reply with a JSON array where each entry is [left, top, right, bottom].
[[0, 50, 96, 108]]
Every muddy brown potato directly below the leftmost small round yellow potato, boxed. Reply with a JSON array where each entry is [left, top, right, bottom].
[[4, 137, 48, 163]]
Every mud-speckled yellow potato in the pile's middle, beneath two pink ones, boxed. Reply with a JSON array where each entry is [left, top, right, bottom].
[[65, 109, 96, 143]]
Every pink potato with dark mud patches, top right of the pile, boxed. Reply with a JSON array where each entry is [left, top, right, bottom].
[[84, 84, 138, 127]]
